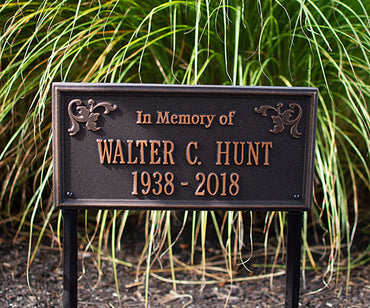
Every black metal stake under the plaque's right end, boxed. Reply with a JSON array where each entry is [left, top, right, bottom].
[[285, 212, 303, 308]]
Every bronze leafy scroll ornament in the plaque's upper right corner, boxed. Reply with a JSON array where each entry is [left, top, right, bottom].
[[254, 103, 302, 138]]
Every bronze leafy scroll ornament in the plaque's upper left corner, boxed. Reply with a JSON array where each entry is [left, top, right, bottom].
[[68, 99, 117, 136]]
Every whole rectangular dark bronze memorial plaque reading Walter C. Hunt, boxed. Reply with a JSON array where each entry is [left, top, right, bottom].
[[53, 83, 317, 210]]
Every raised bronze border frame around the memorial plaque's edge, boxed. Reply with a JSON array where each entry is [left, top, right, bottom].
[[52, 82, 318, 211]]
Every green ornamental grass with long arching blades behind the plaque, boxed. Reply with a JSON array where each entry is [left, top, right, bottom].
[[0, 0, 370, 304]]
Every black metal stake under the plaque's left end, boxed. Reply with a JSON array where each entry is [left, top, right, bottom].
[[62, 210, 78, 308]]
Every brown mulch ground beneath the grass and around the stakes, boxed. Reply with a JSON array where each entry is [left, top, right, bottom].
[[0, 241, 370, 308]]
